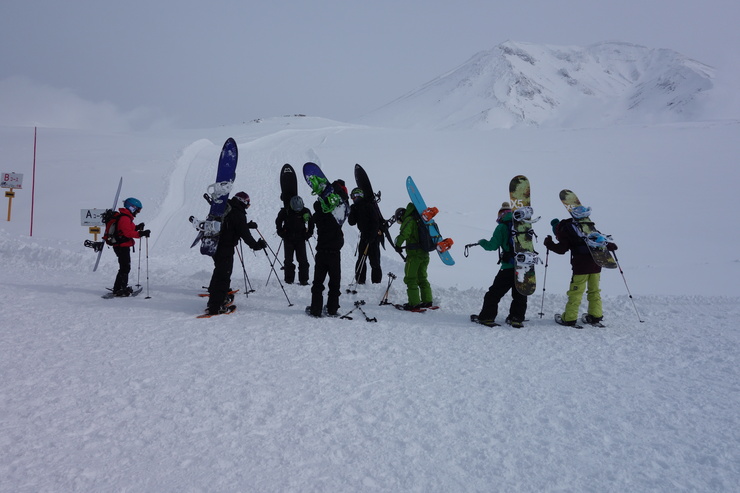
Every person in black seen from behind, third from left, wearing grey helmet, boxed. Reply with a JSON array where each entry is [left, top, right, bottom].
[[275, 195, 314, 286]]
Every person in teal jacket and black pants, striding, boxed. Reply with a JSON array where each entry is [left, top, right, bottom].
[[478, 202, 527, 328]]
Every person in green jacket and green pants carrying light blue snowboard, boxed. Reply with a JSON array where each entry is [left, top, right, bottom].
[[394, 202, 432, 310]]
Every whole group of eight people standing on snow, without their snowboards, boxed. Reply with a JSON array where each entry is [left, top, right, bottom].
[[102, 184, 617, 328]]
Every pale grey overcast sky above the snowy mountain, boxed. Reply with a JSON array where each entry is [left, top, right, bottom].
[[0, 0, 740, 128]]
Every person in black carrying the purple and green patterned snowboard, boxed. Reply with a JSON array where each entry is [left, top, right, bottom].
[[306, 181, 348, 317]]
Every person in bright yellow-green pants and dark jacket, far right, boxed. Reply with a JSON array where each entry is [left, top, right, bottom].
[[544, 218, 617, 326]]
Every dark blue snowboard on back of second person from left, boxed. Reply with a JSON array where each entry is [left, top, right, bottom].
[[190, 137, 239, 256]]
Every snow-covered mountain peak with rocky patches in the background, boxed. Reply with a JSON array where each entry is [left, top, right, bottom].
[[361, 41, 714, 129]]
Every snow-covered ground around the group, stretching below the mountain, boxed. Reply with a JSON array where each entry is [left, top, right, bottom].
[[0, 118, 740, 492]]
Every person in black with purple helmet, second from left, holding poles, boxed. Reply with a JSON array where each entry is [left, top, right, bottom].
[[206, 192, 267, 315]]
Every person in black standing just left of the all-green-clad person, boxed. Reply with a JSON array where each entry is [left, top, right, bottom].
[[347, 188, 383, 284]]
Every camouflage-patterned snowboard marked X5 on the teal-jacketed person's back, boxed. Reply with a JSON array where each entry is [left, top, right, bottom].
[[509, 175, 540, 296]]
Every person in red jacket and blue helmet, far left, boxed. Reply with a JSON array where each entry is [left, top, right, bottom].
[[113, 197, 150, 297]]
